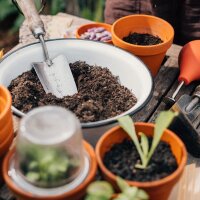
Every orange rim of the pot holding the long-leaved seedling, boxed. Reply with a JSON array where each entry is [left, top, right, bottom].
[[95, 122, 187, 188]]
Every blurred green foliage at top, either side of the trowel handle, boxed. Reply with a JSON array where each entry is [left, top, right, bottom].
[[0, 0, 105, 32]]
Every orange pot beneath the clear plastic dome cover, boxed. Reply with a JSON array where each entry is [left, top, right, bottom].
[[3, 142, 97, 200]]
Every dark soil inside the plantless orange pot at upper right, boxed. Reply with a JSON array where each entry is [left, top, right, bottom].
[[123, 33, 163, 46]]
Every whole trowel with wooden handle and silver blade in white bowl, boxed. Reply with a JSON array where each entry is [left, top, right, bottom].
[[15, 0, 77, 98]]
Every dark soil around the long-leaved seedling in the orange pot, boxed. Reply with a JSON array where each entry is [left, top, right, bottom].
[[103, 138, 178, 182]]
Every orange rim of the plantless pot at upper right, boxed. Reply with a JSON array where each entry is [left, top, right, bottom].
[[111, 14, 174, 55]]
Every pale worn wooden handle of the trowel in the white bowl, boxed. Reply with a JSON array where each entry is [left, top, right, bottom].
[[15, 0, 45, 39]]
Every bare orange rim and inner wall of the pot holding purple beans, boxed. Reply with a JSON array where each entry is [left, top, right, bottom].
[[76, 22, 112, 44]]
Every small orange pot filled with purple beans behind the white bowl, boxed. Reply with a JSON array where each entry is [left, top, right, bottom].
[[76, 22, 112, 44]]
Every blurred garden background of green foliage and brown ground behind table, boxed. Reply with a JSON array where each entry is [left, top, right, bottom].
[[0, 0, 105, 52]]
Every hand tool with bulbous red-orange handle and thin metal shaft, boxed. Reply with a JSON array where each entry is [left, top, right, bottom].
[[163, 40, 200, 106]]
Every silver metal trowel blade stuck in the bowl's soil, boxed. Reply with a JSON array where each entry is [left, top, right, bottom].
[[32, 55, 77, 98]]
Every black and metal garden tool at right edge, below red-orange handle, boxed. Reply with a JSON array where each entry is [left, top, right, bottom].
[[169, 85, 200, 157]]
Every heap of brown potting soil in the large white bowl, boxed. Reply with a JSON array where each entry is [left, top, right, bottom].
[[9, 61, 137, 122]]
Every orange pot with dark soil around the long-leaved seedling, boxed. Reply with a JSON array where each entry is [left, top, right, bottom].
[[95, 122, 187, 200]]
